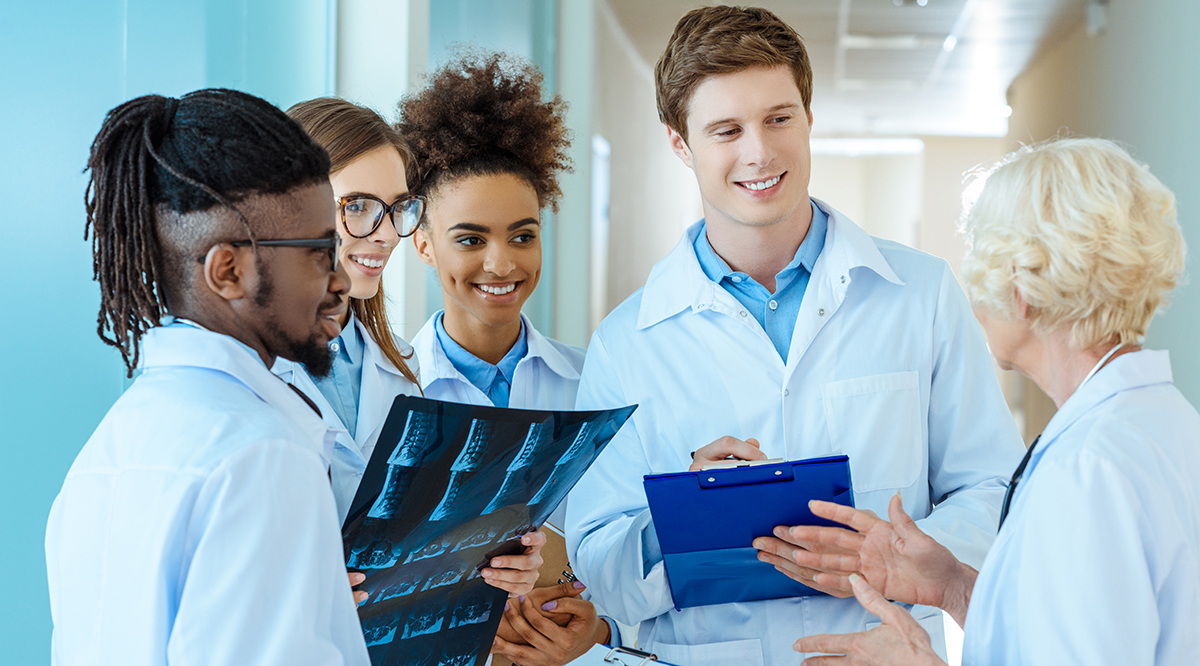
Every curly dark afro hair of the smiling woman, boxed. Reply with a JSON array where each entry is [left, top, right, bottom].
[[396, 53, 571, 211]]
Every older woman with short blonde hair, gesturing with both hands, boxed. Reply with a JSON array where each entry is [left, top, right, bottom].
[[763, 139, 1200, 665]]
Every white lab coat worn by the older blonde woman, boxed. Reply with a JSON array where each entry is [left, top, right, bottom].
[[962, 350, 1200, 666]]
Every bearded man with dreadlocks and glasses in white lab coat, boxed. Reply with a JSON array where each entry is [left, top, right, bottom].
[[46, 90, 368, 666]]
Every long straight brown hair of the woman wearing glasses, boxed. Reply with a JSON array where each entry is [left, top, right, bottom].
[[288, 97, 420, 385]]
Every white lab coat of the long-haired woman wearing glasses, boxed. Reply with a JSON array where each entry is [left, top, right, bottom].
[[271, 317, 421, 522]]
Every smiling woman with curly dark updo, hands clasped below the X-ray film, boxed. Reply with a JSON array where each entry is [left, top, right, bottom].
[[397, 54, 612, 666]]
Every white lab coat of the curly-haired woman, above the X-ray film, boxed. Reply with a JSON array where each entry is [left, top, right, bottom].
[[413, 312, 583, 409]]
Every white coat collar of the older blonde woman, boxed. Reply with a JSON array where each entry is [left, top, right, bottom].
[[1030, 349, 1172, 464]]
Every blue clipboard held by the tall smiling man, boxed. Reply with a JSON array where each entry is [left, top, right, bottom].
[[643, 456, 854, 610]]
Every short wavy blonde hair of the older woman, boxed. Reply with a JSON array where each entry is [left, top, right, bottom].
[[962, 138, 1187, 349]]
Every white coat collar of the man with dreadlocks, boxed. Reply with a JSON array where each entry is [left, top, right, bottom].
[[138, 319, 334, 466]]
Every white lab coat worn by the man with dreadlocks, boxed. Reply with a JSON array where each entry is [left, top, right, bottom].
[[46, 325, 370, 666]]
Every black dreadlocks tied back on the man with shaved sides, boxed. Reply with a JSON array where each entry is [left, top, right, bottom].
[[84, 89, 329, 377]]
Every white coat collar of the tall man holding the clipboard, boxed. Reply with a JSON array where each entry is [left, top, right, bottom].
[[637, 199, 904, 329]]
